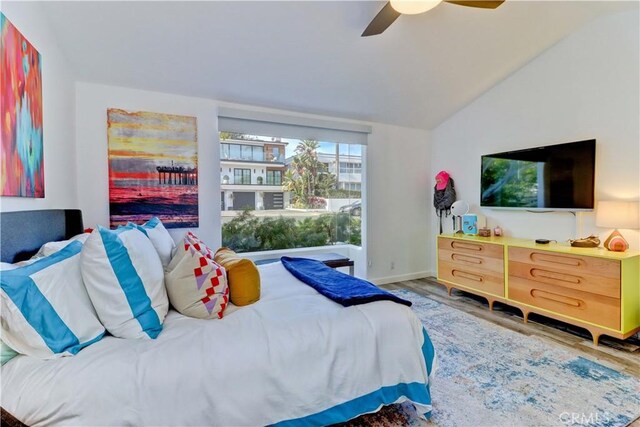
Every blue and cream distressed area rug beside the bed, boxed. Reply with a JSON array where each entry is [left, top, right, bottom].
[[345, 290, 640, 427]]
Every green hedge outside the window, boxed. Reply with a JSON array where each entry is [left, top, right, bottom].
[[222, 210, 361, 252]]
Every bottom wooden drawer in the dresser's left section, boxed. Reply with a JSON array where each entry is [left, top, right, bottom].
[[438, 260, 504, 297]]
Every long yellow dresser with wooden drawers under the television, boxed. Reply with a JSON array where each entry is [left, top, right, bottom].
[[438, 235, 640, 345]]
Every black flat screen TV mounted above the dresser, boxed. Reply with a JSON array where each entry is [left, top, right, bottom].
[[480, 139, 596, 210]]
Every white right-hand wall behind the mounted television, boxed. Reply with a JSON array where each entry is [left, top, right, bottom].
[[430, 12, 640, 271]]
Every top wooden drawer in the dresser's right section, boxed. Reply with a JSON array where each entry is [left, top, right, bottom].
[[508, 247, 620, 281]]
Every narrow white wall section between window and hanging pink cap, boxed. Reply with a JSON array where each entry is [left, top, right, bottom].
[[365, 124, 432, 284]]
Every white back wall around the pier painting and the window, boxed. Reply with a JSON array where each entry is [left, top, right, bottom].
[[76, 83, 430, 282]]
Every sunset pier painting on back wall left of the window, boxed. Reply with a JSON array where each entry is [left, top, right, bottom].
[[107, 109, 198, 228]]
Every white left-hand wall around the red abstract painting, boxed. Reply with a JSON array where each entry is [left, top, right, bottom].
[[0, 2, 78, 212]]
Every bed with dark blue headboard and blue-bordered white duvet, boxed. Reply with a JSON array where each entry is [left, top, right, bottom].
[[1, 211, 435, 426]]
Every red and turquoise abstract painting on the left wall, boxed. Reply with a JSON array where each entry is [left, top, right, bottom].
[[0, 13, 44, 198]]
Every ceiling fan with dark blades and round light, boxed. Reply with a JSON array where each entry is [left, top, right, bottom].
[[362, 0, 504, 37]]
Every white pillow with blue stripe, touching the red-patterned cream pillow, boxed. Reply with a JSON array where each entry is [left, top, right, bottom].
[[81, 225, 169, 338]]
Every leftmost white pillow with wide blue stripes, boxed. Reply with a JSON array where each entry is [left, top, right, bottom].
[[0, 242, 104, 359]]
